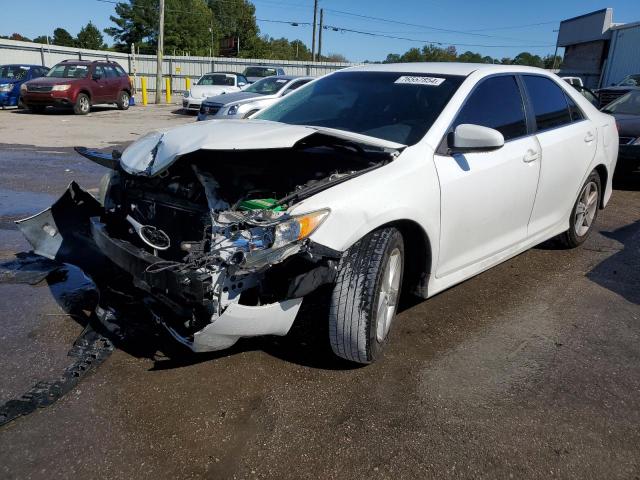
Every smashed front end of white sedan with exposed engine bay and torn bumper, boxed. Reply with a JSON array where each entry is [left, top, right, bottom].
[[18, 126, 395, 352]]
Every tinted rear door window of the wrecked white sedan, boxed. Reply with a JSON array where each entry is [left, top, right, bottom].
[[522, 75, 571, 131]]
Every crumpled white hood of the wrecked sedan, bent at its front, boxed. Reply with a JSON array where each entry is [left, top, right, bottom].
[[120, 120, 406, 176]]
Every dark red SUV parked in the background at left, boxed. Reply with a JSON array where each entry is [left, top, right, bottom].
[[20, 60, 131, 115]]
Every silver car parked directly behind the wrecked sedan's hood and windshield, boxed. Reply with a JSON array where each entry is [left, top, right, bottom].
[[198, 75, 313, 120]]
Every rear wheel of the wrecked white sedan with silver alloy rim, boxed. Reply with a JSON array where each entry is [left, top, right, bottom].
[[559, 171, 602, 248]]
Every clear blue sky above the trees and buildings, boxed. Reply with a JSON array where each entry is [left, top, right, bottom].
[[0, 0, 640, 63]]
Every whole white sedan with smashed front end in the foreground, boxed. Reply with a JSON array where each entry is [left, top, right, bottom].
[[20, 63, 618, 363]]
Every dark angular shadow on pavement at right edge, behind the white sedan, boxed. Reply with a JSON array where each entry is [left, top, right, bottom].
[[587, 220, 640, 305]]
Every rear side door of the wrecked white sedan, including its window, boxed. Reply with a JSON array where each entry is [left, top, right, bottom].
[[522, 75, 598, 235]]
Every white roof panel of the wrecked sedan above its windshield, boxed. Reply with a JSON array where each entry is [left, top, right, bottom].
[[338, 62, 548, 77]]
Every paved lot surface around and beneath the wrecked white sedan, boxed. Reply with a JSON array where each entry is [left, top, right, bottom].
[[0, 109, 640, 479]]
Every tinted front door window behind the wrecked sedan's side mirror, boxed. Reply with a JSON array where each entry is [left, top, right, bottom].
[[453, 75, 527, 141]]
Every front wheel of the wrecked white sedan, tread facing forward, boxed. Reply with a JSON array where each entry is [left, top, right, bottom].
[[329, 228, 404, 364]]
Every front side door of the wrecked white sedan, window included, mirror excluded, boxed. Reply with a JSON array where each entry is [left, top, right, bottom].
[[434, 75, 541, 278]]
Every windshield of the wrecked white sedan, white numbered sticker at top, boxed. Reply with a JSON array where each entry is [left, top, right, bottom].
[[253, 72, 464, 145]]
